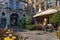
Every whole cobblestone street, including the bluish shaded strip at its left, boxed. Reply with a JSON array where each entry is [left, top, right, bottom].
[[7, 27, 59, 40]]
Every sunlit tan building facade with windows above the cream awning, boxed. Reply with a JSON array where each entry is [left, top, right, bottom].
[[28, 0, 60, 14]]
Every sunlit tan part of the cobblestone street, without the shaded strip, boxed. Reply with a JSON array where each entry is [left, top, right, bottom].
[[17, 31, 59, 40]]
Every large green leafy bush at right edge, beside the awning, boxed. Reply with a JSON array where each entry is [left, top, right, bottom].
[[49, 12, 60, 24]]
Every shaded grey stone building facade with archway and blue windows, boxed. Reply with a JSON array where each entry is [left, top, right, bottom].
[[0, 0, 28, 26]]
